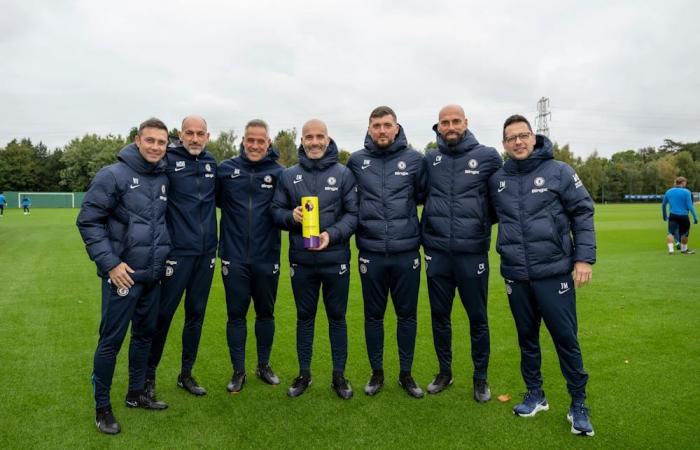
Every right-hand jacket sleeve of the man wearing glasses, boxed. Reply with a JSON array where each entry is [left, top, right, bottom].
[[559, 164, 596, 264]]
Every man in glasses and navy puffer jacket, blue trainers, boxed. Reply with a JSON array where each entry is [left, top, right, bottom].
[[489, 115, 596, 436]]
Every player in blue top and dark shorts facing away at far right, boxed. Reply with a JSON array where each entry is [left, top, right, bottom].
[[661, 177, 698, 255]]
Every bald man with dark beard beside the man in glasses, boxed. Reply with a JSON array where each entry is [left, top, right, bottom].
[[421, 105, 503, 402]]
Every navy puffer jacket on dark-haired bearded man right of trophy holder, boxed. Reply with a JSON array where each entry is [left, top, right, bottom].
[[348, 125, 427, 254]]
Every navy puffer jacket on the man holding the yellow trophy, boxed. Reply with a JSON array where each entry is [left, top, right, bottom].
[[272, 139, 357, 265]]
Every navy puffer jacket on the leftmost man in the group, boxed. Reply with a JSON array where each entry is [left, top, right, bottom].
[[77, 144, 170, 283]]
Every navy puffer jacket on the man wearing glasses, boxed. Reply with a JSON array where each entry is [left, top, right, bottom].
[[489, 135, 596, 280]]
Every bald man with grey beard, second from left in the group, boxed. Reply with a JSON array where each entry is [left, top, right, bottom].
[[146, 116, 217, 399]]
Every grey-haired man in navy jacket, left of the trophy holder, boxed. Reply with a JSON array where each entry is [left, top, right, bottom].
[[217, 119, 284, 393]]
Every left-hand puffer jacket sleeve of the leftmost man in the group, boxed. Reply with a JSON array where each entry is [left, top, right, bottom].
[[76, 169, 121, 274]]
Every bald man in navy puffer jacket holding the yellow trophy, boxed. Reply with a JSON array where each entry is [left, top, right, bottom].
[[272, 119, 357, 400]]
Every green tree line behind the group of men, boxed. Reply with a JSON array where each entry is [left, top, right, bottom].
[[0, 127, 700, 202]]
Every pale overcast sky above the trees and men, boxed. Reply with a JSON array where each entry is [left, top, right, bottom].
[[0, 0, 700, 156]]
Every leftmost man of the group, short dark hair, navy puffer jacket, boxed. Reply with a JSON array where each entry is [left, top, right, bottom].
[[77, 119, 170, 434]]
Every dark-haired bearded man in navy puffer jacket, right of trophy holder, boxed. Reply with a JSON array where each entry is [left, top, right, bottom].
[[348, 106, 426, 398]]
